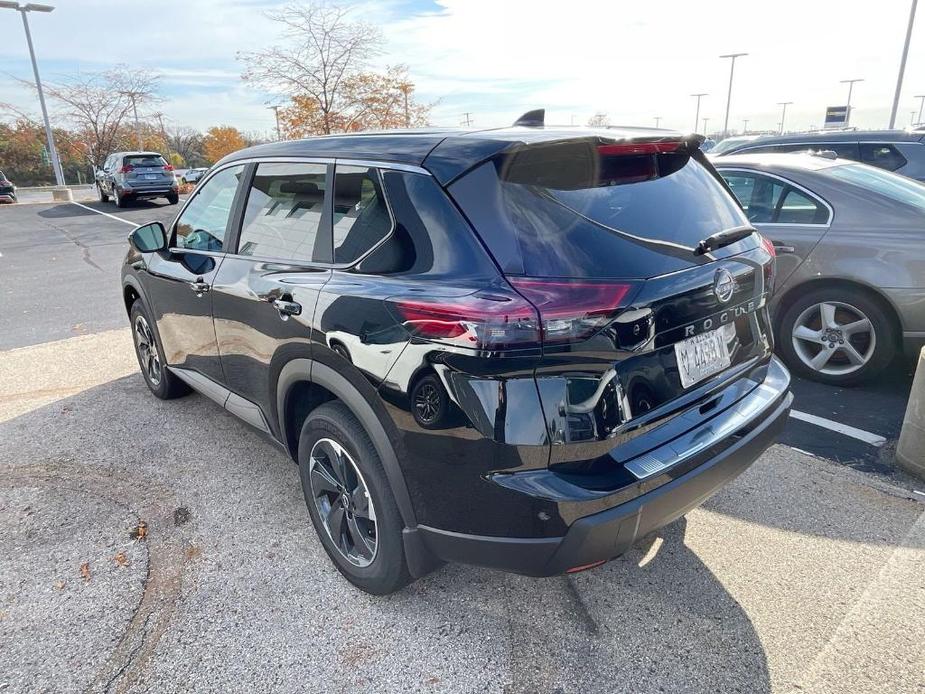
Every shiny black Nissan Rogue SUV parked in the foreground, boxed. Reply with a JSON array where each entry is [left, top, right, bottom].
[[122, 118, 792, 593]]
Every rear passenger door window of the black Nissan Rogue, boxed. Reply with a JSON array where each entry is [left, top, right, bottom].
[[238, 164, 327, 260]]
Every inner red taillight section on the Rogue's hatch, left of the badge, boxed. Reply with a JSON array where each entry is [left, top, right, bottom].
[[508, 277, 633, 344]]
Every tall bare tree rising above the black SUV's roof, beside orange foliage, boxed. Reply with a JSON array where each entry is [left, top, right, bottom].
[[238, 2, 382, 134]]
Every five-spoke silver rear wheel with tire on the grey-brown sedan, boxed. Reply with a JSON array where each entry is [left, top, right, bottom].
[[778, 286, 896, 386]]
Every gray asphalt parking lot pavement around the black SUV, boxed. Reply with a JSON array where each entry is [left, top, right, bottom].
[[0, 202, 925, 693]]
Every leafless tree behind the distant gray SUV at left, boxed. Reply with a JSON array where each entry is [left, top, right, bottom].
[[35, 65, 157, 166]]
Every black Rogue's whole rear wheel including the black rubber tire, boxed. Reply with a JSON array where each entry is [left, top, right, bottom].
[[299, 401, 412, 595]]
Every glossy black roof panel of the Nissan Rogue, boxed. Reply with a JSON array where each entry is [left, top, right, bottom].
[[219, 127, 682, 184]]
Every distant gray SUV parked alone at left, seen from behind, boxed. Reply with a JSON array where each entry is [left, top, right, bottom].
[[96, 152, 180, 207]]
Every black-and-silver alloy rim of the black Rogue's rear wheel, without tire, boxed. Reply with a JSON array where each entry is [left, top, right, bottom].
[[309, 439, 379, 567]]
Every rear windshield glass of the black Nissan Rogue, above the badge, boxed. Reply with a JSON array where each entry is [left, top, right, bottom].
[[450, 141, 754, 277]]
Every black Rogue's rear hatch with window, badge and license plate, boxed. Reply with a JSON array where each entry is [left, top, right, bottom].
[[448, 137, 774, 465]]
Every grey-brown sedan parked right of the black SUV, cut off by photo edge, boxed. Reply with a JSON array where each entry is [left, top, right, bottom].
[[714, 154, 925, 385]]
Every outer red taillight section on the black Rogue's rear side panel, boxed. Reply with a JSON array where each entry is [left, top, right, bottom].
[[390, 292, 540, 350]]
